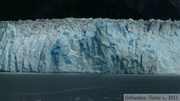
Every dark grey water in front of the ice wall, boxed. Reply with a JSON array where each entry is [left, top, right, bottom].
[[0, 74, 180, 101]]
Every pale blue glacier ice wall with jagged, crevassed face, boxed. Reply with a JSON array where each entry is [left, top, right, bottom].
[[0, 18, 180, 74]]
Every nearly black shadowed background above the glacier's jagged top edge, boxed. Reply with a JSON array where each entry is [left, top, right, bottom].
[[0, 0, 180, 21]]
